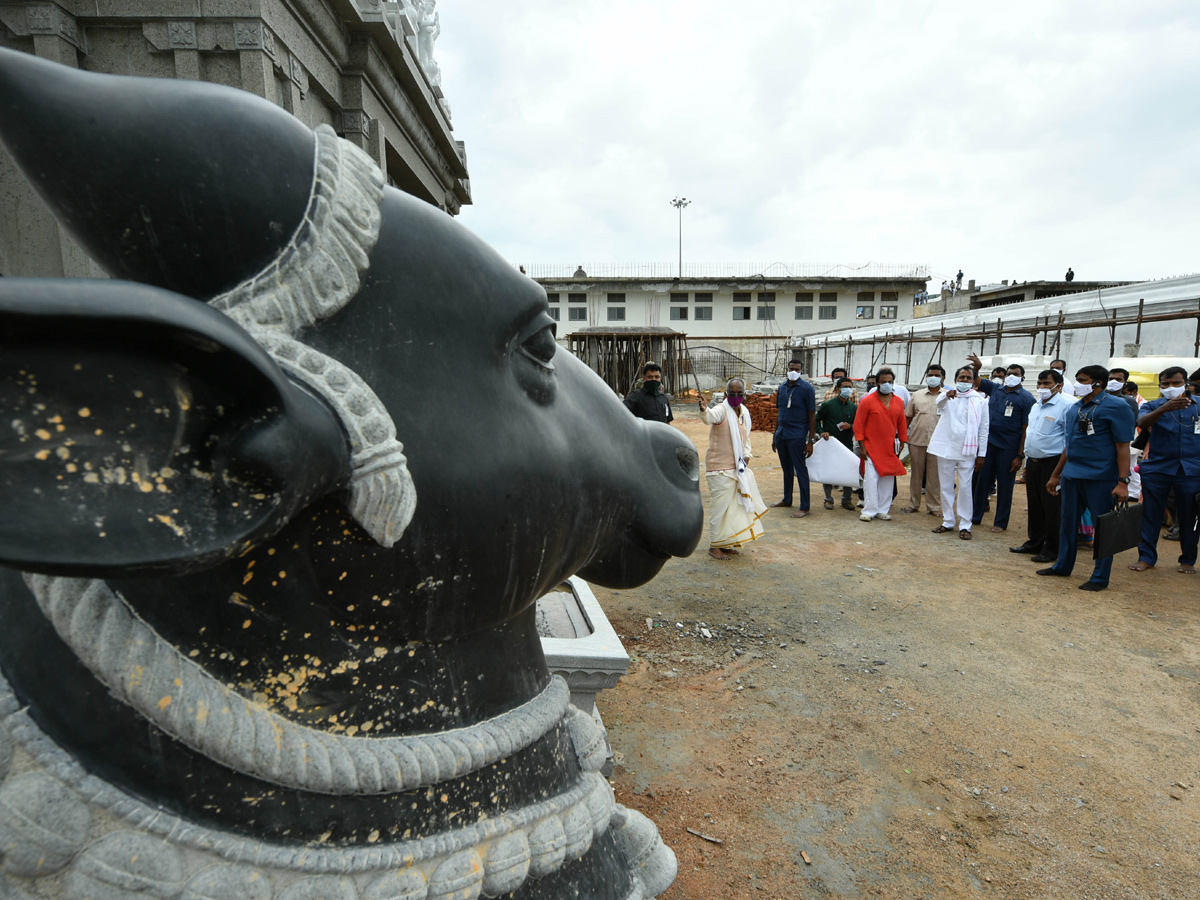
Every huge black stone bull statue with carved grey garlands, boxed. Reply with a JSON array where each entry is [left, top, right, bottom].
[[0, 50, 702, 900]]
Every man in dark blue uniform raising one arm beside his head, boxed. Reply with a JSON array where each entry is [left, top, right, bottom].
[[968, 354, 1036, 532]]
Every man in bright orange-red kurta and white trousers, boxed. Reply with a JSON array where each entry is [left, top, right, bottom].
[[854, 368, 908, 522]]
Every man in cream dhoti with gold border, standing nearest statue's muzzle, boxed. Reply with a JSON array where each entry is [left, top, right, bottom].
[[700, 378, 767, 562]]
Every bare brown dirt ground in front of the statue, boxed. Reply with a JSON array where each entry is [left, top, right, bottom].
[[596, 410, 1200, 900]]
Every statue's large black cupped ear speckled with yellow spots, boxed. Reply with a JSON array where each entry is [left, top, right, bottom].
[[0, 278, 350, 577]]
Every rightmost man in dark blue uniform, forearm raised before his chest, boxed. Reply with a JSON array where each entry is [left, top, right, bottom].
[[1129, 366, 1200, 575]]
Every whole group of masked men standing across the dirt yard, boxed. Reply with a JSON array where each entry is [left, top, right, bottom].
[[626, 355, 1200, 590]]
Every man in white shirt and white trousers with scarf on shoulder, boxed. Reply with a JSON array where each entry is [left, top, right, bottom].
[[926, 366, 989, 541]]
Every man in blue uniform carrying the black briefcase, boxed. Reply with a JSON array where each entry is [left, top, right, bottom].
[[1038, 366, 1133, 590]]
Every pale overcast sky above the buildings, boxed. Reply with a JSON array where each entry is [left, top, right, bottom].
[[436, 0, 1200, 282]]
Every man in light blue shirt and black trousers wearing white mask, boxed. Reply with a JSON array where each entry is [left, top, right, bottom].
[[1009, 368, 1075, 563]]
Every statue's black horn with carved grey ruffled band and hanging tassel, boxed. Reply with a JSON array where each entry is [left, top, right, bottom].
[[0, 50, 416, 556]]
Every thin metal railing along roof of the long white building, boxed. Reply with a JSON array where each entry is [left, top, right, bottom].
[[526, 263, 930, 281]]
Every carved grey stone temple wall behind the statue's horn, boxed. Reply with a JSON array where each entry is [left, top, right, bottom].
[[0, 0, 472, 277]]
